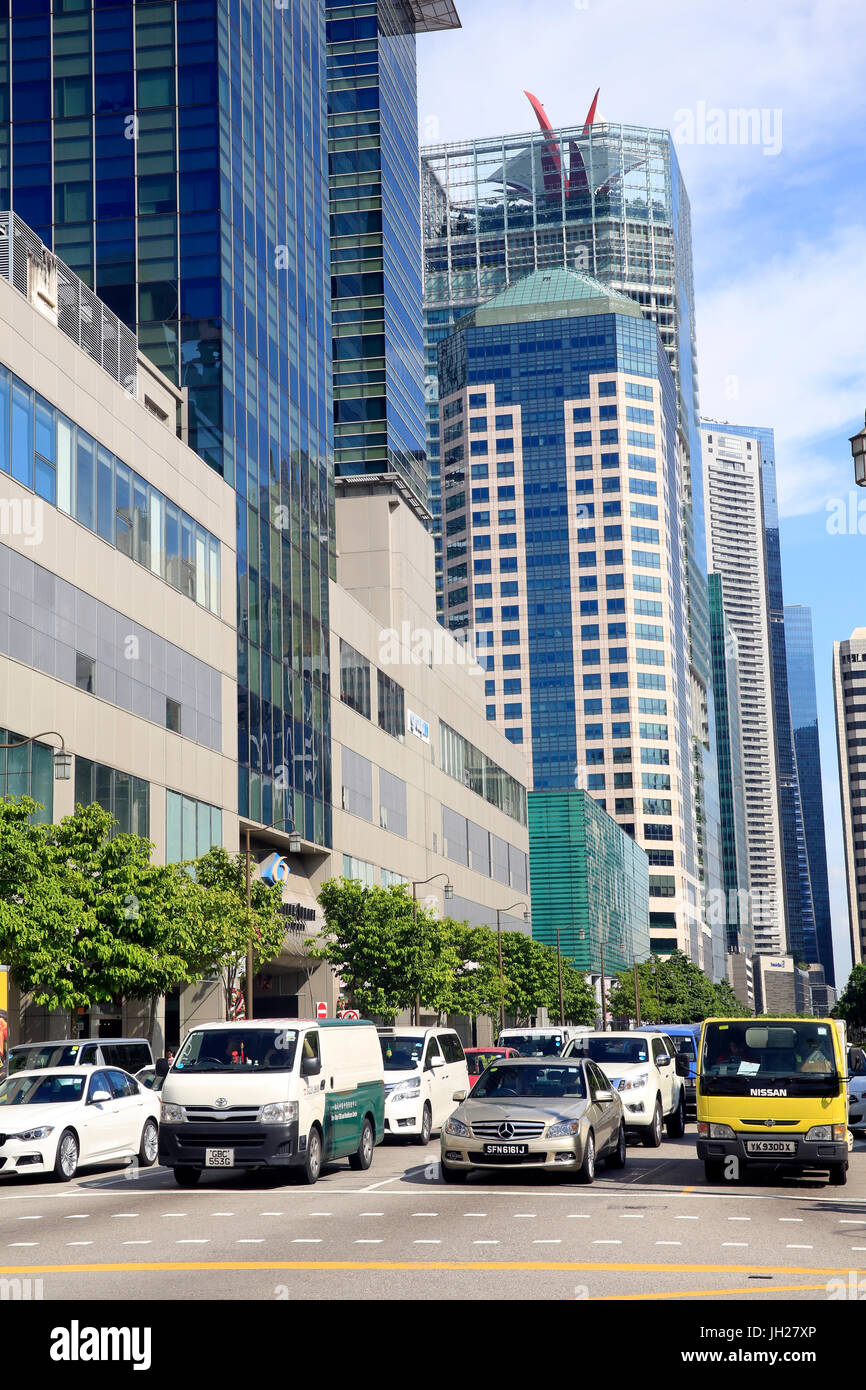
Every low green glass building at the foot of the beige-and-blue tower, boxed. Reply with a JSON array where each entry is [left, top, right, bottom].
[[528, 788, 649, 976]]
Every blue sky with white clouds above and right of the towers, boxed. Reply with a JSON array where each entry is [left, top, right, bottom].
[[418, 0, 866, 984]]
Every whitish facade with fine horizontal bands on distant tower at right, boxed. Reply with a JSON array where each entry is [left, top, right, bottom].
[[702, 421, 787, 955]]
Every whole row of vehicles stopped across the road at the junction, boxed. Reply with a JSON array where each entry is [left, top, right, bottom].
[[0, 1017, 866, 1187]]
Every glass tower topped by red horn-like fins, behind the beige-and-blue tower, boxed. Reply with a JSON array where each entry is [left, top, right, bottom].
[[421, 97, 719, 961]]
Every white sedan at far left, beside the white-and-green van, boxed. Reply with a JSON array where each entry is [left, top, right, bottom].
[[0, 1068, 160, 1183]]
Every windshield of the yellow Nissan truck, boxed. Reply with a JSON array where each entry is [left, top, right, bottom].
[[701, 1019, 838, 1095]]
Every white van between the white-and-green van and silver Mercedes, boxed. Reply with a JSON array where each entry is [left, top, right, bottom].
[[378, 1027, 468, 1144]]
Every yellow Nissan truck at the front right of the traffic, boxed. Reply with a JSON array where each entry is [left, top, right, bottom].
[[696, 1017, 848, 1186]]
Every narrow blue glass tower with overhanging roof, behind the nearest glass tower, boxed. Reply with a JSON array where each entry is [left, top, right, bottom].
[[327, 0, 460, 502]]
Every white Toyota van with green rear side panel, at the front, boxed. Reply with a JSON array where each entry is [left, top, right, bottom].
[[156, 1019, 385, 1187]]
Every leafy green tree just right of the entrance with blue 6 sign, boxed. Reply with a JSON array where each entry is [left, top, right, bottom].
[[314, 878, 460, 1023]]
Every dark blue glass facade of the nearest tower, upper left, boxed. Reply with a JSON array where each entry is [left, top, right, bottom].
[[0, 0, 334, 844]]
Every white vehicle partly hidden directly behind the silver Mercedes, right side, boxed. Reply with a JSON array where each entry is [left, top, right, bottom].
[[563, 1033, 688, 1148]]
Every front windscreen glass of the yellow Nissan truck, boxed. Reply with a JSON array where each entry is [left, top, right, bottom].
[[702, 1019, 837, 1081]]
